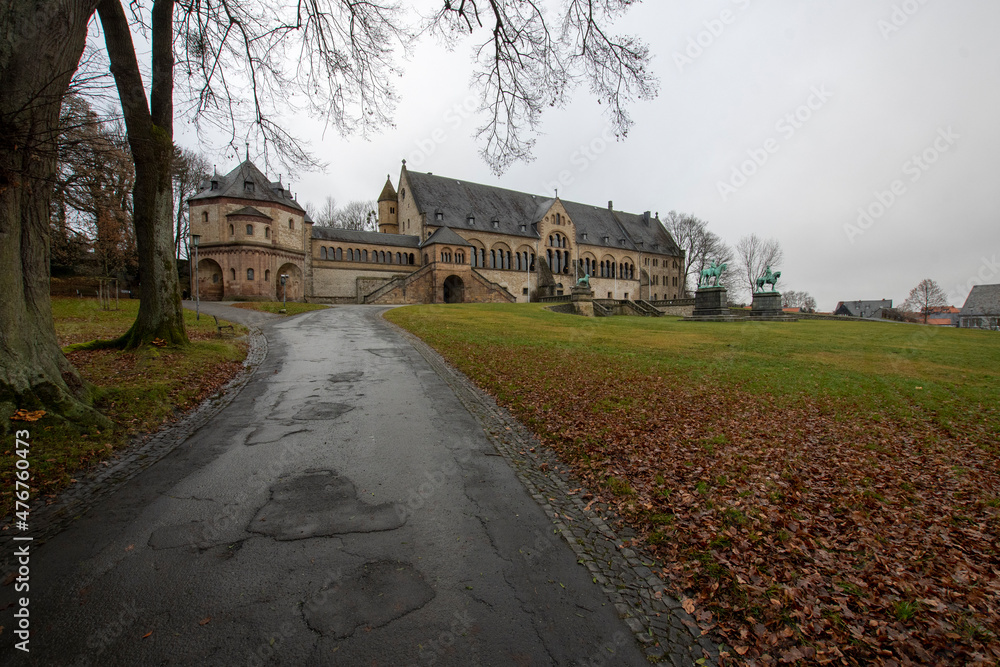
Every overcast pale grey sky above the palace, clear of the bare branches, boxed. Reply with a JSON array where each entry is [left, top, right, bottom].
[[177, 0, 1000, 310]]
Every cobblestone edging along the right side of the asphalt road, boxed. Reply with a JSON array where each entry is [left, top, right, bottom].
[[390, 323, 719, 665]]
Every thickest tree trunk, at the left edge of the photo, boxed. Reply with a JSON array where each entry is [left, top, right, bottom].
[[0, 0, 107, 432]]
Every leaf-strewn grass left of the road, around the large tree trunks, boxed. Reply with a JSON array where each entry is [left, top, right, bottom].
[[0, 298, 246, 515]]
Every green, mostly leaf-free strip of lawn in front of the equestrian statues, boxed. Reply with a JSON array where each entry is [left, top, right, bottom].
[[386, 304, 1000, 439]]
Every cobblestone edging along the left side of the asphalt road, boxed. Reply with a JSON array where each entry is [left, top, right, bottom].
[[5, 326, 267, 545]]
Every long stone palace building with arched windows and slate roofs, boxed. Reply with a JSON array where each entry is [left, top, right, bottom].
[[188, 160, 684, 304]]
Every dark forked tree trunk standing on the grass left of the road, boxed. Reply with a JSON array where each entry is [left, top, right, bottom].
[[97, 0, 188, 347]]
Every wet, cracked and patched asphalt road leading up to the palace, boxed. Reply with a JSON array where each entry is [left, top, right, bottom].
[[0, 304, 647, 666]]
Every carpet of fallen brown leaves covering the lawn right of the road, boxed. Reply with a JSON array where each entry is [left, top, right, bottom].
[[445, 345, 1000, 665]]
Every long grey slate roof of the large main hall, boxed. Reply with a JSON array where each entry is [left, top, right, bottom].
[[406, 170, 680, 254]]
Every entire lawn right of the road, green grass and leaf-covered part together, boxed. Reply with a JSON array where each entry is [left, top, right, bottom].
[[385, 304, 1000, 664]]
